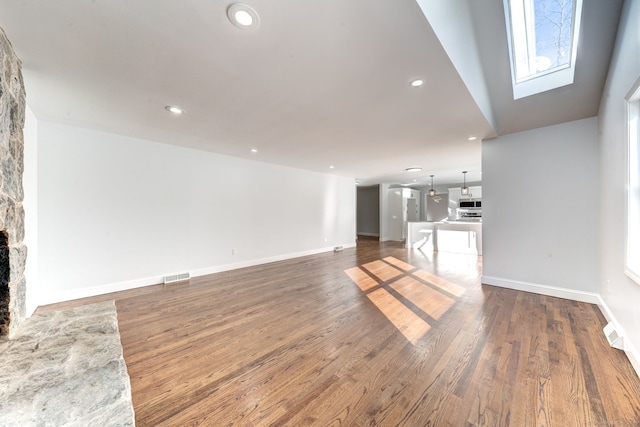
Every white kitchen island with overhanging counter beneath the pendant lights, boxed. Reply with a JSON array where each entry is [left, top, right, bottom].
[[405, 221, 482, 255]]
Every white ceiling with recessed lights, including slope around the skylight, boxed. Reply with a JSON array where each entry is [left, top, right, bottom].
[[0, 0, 622, 185]]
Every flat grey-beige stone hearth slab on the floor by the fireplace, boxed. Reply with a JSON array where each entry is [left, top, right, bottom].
[[0, 301, 135, 427]]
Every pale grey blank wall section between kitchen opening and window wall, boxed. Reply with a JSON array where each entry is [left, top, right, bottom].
[[482, 118, 599, 302]]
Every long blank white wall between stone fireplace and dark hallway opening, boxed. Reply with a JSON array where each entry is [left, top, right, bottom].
[[38, 122, 356, 304]]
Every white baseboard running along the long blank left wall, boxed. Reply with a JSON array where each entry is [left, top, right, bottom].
[[34, 246, 356, 307]]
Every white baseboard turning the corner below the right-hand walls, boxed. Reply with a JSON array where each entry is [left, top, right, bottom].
[[482, 276, 640, 377]]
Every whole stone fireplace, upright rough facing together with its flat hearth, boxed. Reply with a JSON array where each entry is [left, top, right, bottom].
[[0, 28, 135, 427]]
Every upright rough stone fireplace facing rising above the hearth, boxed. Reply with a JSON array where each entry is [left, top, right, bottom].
[[0, 28, 27, 336]]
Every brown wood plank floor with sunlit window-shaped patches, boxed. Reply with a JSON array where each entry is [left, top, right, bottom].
[[38, 240, 640, 427]]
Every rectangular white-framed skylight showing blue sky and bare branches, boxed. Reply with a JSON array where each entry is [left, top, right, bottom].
[[504, 0, 582, 99]]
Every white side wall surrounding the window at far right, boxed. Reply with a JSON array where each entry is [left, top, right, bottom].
[[599, 0, 640, 373]]
